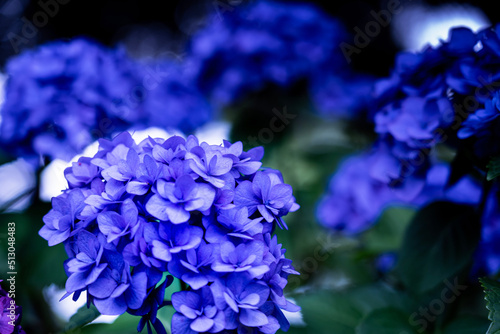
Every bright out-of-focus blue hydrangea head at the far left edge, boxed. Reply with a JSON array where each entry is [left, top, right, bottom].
[[0, 39, 145, 164]]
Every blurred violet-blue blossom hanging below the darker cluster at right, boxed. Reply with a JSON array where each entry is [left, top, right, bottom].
[[317, 151, 481, 235]]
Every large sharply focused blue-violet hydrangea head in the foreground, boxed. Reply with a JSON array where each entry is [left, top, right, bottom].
[[39, 132, 299, 333]]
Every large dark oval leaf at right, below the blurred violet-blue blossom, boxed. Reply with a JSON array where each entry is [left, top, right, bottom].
[[396, 202, 480, 293]]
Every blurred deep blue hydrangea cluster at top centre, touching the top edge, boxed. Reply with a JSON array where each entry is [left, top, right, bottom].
[[188, 0, 371, 116]]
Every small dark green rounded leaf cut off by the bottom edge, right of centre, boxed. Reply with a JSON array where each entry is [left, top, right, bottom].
[[356, 307, 417, 334]]
